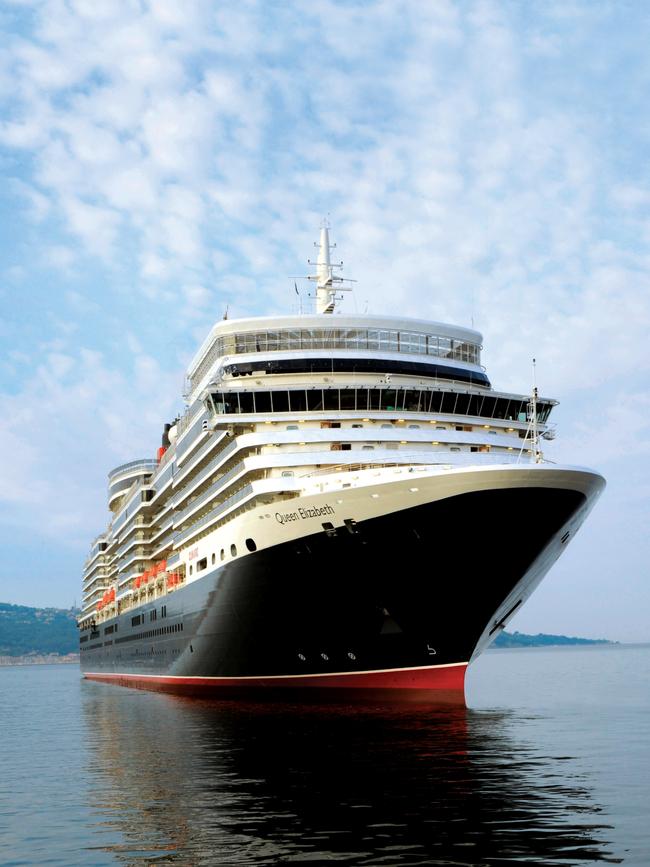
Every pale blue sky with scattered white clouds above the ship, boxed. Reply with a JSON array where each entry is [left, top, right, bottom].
[[0, 0, 650, 641]]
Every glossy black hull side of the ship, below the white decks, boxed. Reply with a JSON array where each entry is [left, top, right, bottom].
[[80, 487, 586, 689]]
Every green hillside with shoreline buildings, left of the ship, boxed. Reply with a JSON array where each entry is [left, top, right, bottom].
[[0, 602, 79, 656]]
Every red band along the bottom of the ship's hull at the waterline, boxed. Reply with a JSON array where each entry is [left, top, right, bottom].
[[84, 662, 467, 704]]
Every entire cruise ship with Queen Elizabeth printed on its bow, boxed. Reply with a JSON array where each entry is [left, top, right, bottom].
[[79, 227, 605, 702]]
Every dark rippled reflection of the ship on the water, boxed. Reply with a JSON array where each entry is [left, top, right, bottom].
[[83, 683, 616, 865]]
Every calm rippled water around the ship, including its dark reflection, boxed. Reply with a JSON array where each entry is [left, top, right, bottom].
[[0, 647, 650, 867]]
